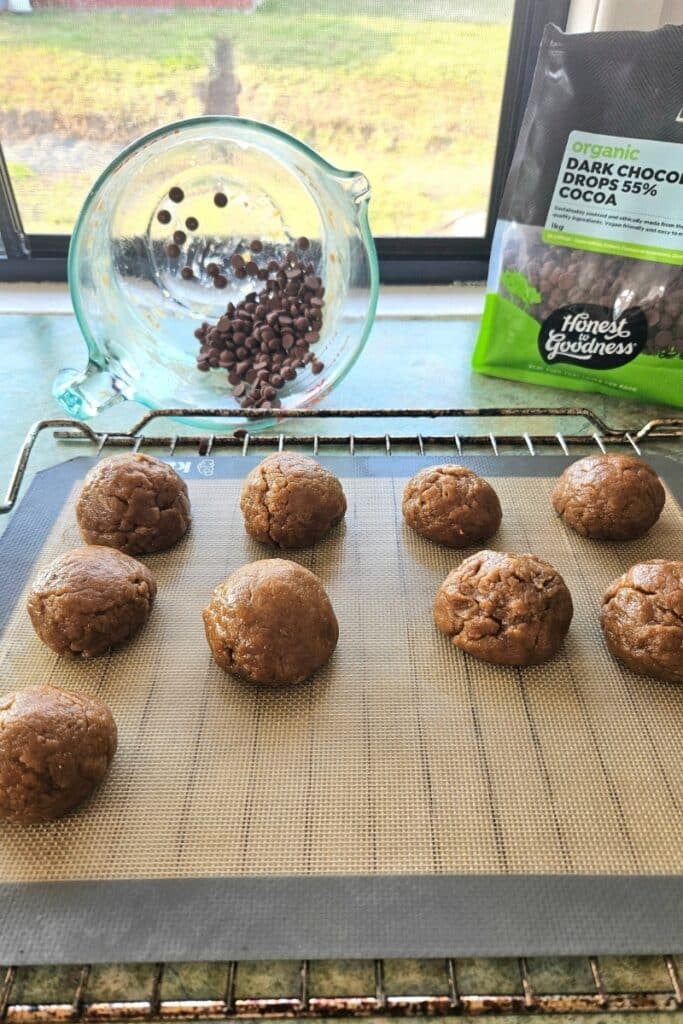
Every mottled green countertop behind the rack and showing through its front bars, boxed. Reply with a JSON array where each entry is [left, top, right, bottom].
[[0, 314, 683, 1020]]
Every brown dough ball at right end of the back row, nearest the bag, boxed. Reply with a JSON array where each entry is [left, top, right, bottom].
[[552, 455, 665, 541]]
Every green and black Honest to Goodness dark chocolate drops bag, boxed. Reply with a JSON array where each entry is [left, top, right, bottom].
[[472, 25, 683, 407]]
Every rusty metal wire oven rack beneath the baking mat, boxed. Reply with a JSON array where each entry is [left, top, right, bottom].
[[0, 407, 683, 1024]]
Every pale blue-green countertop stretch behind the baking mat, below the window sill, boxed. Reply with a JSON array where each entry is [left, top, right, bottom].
[[0, 314, 683, 503]]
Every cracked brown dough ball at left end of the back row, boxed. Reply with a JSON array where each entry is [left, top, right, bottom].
[[76, 453, 191, 555]]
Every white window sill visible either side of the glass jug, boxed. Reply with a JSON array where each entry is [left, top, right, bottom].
[[0, 283, 485, 321]]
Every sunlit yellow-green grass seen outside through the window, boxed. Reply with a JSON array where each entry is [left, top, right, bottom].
[[0, 0, 509, 234]]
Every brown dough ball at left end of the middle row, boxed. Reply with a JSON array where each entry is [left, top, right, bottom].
[[28, 544, 157, 657]]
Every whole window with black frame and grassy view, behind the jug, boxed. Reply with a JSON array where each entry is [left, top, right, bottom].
[[0, 0, 567, 280]]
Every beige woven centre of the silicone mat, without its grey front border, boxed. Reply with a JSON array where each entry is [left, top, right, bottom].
[[0, 457, 683, 883]]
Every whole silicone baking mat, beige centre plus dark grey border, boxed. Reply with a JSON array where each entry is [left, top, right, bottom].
[[0, 442, 683, 964]]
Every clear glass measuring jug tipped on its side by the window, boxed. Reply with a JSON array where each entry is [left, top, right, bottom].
[[53, 117, 379, 430]]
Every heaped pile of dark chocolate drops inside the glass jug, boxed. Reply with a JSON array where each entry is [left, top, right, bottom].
[[195, 237, 325, 409]]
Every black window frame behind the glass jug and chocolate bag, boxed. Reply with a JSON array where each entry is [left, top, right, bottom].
[[0, 0, 570, 285]]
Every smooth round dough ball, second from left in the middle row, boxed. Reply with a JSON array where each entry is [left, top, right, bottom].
[[204, 558, 339, 686]]
